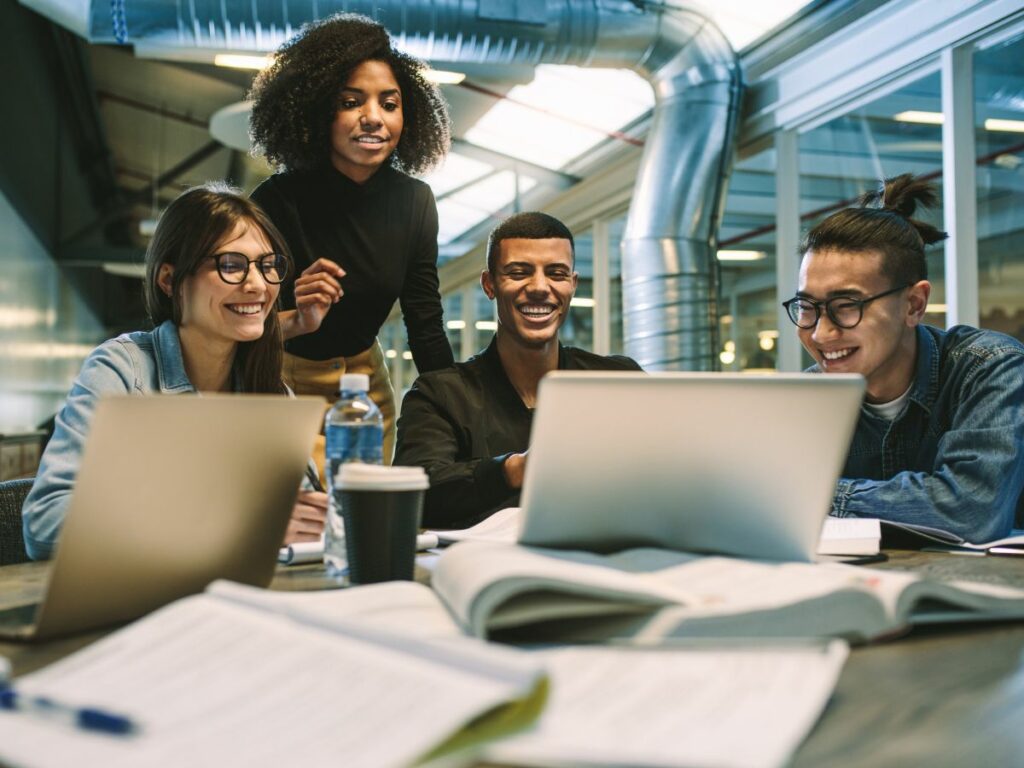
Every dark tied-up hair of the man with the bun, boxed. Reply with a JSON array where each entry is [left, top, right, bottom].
[[800, 173, 947, 286]]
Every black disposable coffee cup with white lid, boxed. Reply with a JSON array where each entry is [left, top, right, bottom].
[[335, 463, 430, 584]]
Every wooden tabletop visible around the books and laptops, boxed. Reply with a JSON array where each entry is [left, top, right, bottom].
[[0, 551, 1024, 768]]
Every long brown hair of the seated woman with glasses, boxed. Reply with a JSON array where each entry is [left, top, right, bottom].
[[143, 183, 293, 393]]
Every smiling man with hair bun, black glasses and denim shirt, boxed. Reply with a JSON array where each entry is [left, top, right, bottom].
[[783, 174, 1024, 543]]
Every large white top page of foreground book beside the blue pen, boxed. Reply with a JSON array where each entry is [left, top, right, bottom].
[[0, 595, 537, 768]]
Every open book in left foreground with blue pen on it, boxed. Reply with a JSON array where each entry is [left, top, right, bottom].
[[0, 582, 547, 768]]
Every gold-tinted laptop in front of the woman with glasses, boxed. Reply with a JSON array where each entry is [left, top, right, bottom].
[[0, 395, 324, 639]]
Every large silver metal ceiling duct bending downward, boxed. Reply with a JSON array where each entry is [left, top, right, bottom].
[[23, 0, 742, 370]]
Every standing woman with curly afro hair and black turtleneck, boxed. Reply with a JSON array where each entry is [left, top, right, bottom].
[[251, 14, 454, 473]]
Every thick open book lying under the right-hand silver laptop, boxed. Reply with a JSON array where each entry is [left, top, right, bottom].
[[433, 542, 1024, 643]]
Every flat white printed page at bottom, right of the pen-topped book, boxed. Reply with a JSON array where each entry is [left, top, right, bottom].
[[486, 641, 847, 768]]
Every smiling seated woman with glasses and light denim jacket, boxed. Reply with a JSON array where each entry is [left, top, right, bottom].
[[22, 184, 334, 560]]
